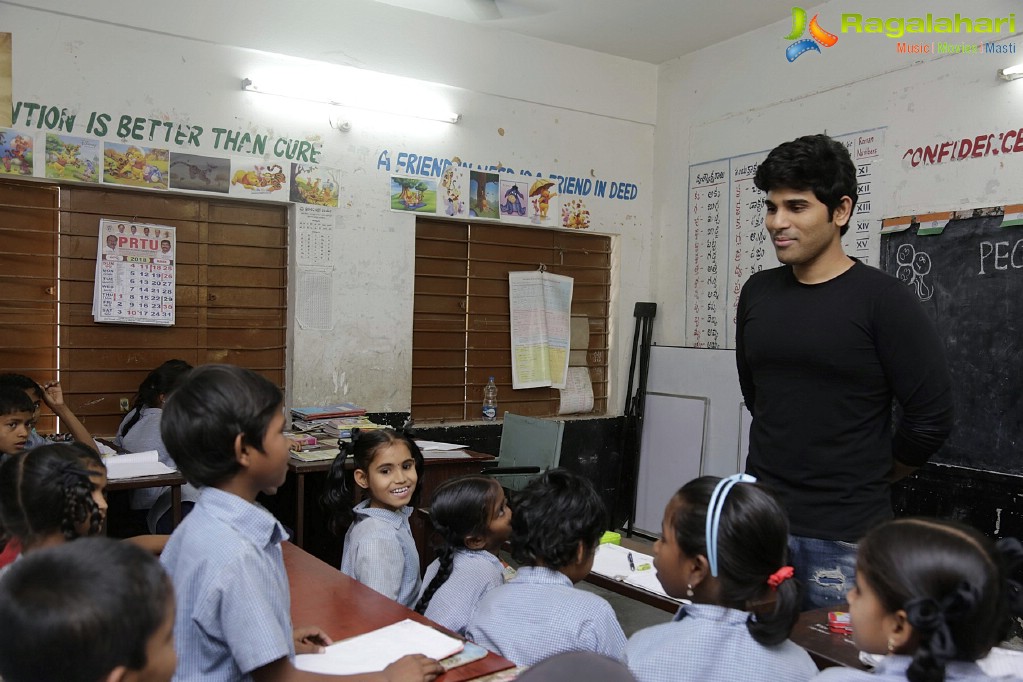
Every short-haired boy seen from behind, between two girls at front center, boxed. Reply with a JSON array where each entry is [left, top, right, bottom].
[[465, 469, 625, 666]]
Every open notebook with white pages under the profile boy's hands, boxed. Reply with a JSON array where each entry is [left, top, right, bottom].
[[295, 619, 463, 675]]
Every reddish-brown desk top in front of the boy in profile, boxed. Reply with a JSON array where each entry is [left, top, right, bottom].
[[281, 542, 515, 682]]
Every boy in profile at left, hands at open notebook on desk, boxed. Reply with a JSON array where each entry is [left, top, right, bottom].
[[161, 365, 442, 682]]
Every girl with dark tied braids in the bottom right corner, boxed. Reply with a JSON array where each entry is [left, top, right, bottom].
[[815, 518, 1023, 682]]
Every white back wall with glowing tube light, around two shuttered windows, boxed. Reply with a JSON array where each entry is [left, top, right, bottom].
[[7, 0, 657, 412]]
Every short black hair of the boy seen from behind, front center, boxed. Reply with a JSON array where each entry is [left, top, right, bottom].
[[512, 468, 608, 571]]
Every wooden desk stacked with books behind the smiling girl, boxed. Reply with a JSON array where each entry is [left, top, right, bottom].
[[287, 450, 496, 556]]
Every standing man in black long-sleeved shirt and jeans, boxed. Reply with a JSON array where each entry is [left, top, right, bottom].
[[736, 135, 952, 607]]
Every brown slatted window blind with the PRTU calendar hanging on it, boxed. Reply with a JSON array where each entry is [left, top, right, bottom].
[[0, 182, 287, 435]]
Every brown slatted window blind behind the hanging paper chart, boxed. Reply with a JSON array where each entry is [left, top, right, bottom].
[[412, 218, 612, 421]]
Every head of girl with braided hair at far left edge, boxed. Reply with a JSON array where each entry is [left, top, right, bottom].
[[0, 443, 106, 569]]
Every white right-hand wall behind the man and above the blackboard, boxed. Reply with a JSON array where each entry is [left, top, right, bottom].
[[651, 0, 1023, 473]]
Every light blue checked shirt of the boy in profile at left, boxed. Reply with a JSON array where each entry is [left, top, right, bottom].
[[160, 488, 295, 682]]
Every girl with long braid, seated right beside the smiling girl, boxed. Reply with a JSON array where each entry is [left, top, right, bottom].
[[415, 474, 512, 636]]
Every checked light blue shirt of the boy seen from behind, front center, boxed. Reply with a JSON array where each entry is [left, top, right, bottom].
[[465, 566, 625, 666]]
